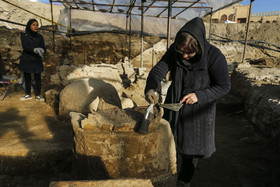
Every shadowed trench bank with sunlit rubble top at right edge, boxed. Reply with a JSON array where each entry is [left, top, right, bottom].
[[232, 67, 280, 137]]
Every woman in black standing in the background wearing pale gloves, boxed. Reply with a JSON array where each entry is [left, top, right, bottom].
[[19, 19, 46, 101]]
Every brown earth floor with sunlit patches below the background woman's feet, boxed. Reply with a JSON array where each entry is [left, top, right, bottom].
[[0, 89, 73, 187]]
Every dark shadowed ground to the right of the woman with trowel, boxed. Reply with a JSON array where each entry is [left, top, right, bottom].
[[191, 100, 280, 187]]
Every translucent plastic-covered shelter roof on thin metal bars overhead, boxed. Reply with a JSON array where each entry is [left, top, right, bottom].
[[53, 0, 241, 20]]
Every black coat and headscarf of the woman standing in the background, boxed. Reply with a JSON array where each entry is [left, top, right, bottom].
[[19, 19, 46, 73]]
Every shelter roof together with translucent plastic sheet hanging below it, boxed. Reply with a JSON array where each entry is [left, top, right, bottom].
[[50, 0, 242, 67]]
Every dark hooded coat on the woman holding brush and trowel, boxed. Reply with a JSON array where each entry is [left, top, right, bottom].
[[145, 18, 230, 158]]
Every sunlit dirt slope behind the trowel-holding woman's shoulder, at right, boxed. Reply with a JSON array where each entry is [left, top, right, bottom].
[[206, 23, 280, 67]]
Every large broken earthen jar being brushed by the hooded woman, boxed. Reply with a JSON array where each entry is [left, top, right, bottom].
[[70, 102, 176, 185]]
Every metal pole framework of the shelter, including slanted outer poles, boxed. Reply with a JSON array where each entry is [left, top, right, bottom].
[[2, 0, 254, 67]]
